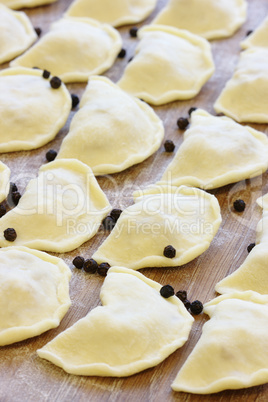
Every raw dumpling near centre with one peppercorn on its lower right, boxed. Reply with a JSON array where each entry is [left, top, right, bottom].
[[92, 186, 221, 269]]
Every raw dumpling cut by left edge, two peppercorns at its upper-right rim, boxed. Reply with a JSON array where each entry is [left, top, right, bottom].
[[0, 67, 72, 152]]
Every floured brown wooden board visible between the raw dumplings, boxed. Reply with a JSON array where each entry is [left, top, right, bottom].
[[0, 0, 268, 402]]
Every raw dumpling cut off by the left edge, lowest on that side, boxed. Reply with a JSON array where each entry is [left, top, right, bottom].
[[0, 247, 71, 346]]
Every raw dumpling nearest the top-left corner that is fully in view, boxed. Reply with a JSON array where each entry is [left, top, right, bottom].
[[11, 17, 122, 82]]
